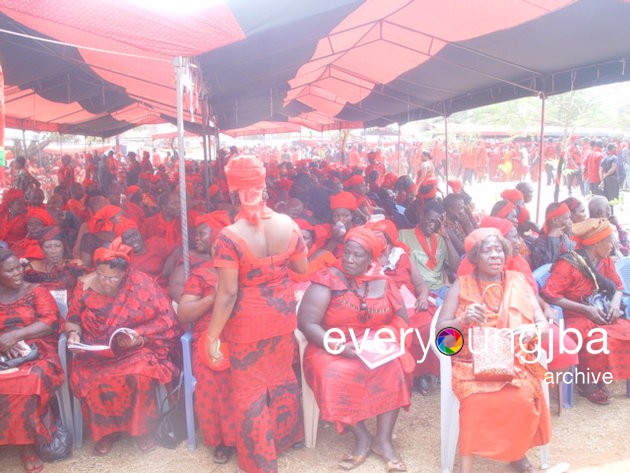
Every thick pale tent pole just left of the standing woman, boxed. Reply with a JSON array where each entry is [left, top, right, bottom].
[[173, 56, 190, 279]]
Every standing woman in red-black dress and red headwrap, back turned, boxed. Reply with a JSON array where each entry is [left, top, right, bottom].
[[207, 156, 306, 473]]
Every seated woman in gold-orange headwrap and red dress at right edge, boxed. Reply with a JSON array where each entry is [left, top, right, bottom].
[[542, 218, 630, 404]]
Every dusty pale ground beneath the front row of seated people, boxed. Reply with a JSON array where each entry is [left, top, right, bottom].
[[0, 382, 630, 473]]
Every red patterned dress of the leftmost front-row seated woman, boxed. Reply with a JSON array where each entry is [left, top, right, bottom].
[[0, 286, 63, 445]]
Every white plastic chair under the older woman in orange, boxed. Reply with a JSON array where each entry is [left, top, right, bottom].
[[430, 308, 549, 473]]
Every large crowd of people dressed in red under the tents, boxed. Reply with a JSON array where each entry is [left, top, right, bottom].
[[0, 141, 630, 473]]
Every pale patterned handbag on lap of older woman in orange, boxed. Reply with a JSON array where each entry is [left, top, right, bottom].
[[470, 326, 515, 381]]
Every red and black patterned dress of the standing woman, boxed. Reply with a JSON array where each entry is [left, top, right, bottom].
[[213, 228, 306, 473]]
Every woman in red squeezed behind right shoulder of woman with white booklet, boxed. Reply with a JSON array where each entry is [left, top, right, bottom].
[[366, 220, 440, 396]]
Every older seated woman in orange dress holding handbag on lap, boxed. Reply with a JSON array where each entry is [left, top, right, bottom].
[[436, 228, 551, 473]]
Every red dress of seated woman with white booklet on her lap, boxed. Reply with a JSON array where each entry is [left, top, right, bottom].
[[304, 269, 410, 431]]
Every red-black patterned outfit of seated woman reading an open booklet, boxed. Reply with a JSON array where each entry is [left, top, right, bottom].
[[68, 271, 181, 441]]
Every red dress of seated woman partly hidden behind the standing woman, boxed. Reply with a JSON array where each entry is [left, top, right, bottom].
[[183, 261, 236, 447]]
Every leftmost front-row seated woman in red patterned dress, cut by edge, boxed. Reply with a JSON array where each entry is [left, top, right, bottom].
[[0, 250, 63, 473]]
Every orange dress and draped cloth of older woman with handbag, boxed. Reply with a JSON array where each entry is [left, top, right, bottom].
[[452, 271, 551, 462]]
